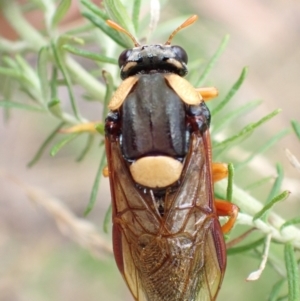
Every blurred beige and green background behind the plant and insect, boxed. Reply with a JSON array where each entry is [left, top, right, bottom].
[[0, 0, 300, 301]]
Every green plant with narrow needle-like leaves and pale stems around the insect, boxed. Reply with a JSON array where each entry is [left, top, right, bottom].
[[0, 0, 300, 301]]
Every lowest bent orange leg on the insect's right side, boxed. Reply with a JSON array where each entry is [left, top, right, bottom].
[[215, 199, 239, 234]]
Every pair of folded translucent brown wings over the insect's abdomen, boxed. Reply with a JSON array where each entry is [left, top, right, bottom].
[[106, 132, 226, 301]]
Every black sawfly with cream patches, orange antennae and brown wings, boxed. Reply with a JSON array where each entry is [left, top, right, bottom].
[[105, 15, 238, 301]]
